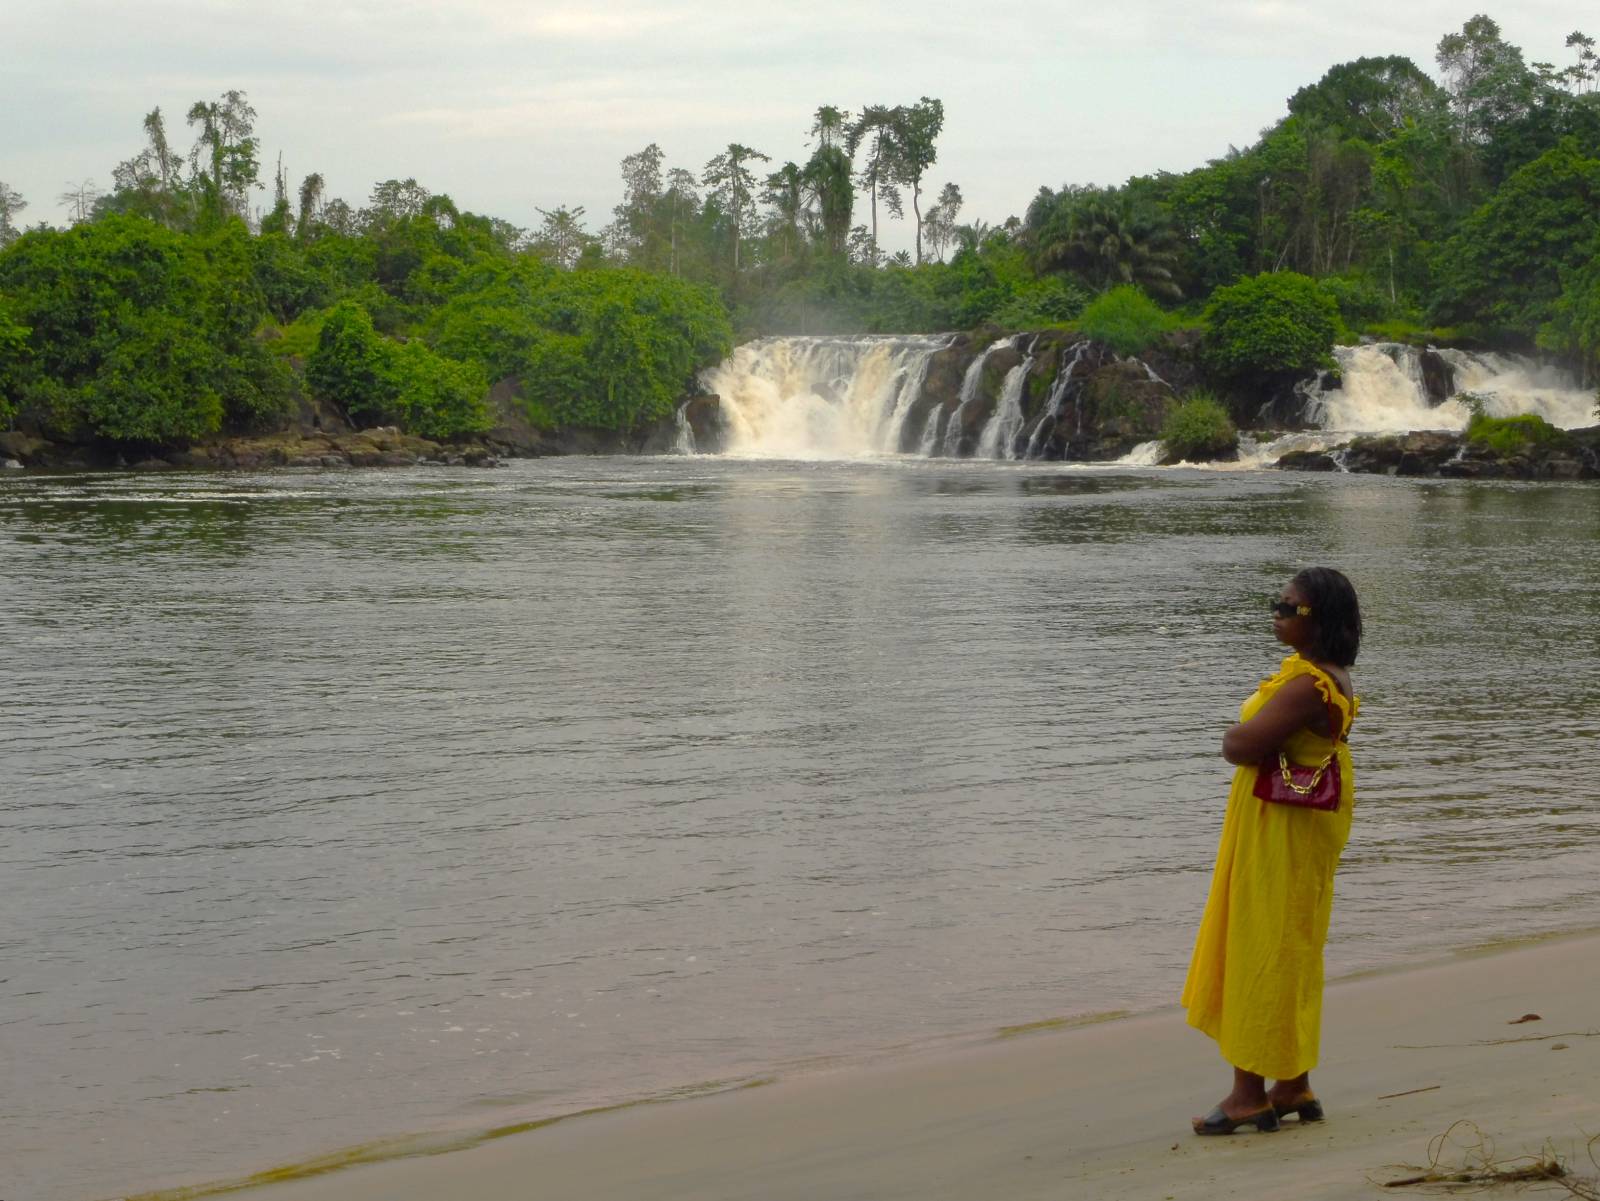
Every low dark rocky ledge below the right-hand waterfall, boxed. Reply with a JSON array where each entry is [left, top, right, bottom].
[[1277, 425, 1600, 480]]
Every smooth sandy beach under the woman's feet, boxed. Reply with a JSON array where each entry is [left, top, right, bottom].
[[193, 934, 1600, 1201]]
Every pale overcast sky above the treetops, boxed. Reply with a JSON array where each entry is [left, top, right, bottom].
[[0, 0, 1600, 246]]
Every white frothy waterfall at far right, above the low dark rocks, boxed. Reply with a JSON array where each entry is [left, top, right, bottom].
[[1306, 342, 1595, 433]]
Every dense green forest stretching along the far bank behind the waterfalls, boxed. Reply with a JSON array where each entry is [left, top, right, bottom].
[[0, 16, 1600, 445]]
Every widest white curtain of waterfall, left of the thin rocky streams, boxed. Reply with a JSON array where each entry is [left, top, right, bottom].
[[701, 334, 950, 459]]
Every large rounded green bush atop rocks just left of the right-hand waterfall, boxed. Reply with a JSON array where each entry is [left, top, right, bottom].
[[1202, 272, 1344, 385]]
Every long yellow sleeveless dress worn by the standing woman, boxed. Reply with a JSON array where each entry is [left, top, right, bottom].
[[1182, 654, 1360, 1079]]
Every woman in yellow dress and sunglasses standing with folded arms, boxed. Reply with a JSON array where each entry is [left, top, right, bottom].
[[1182, 568, 1362, 1134]]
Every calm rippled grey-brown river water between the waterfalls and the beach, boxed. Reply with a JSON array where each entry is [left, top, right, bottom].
[[0, 457, 1600, 1201]]
